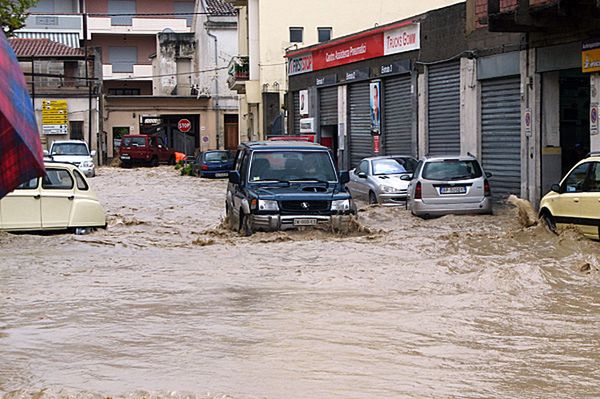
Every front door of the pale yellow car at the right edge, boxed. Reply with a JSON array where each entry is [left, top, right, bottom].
[[552, 162, 591, 231]]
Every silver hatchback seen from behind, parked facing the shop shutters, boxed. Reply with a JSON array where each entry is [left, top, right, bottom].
[[407, 155, 493, 218]]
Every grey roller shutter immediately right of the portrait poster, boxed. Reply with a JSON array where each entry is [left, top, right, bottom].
[[383, 75, 414, 155]]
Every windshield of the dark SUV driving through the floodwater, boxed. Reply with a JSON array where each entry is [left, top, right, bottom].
[[248, 150, 337, 182]]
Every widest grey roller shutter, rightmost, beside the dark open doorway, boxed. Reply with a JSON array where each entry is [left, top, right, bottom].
[[481, 76, 521, 198]]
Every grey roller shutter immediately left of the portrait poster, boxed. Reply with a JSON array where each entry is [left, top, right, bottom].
[[348, 82, 373, 168]]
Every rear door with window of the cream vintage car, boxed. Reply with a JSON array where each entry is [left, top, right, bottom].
[[41, 167, 75, 229]]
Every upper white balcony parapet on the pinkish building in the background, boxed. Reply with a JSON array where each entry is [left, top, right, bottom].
[[88, 17, 192, 39]]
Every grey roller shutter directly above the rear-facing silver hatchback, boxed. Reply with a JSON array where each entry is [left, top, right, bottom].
[[427, 61, 460, 155]]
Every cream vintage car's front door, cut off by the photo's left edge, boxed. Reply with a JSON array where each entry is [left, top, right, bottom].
[[0, 177, 42, 230]]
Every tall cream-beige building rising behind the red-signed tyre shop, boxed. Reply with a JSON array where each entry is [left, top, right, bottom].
[[225, 0, 460, 141]]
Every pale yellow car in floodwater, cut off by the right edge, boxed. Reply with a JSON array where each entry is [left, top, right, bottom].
[[540, 153, 600, 239]]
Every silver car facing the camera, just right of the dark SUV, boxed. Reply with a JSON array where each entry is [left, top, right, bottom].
[[346, 155, 417, 204]]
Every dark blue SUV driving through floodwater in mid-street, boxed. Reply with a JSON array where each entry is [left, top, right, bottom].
[[225, 141, 356, 235]]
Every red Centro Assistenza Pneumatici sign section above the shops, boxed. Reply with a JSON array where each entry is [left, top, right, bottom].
[[313, 33, 383, 71]]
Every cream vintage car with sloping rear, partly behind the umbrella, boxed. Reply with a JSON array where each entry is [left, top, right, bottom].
[[0, 162, 106, 232]]
